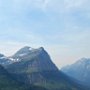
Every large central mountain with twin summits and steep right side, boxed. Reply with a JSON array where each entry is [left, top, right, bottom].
[[7, 46, 88, 90]]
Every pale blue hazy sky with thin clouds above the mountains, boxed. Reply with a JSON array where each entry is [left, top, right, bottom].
[[0, 0, 90, 68]]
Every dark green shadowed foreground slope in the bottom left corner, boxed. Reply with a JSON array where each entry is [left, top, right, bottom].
[[0, 65, 47, 90]]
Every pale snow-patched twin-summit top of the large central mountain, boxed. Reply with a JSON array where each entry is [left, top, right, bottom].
[[10, 46, 47, 61]]
